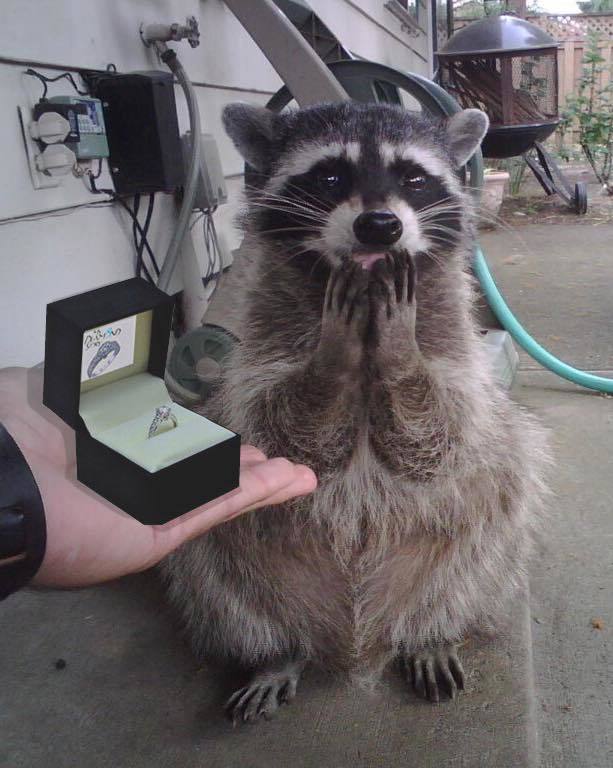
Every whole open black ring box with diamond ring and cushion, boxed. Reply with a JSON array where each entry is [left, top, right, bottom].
[[43, 278, 240, 523]]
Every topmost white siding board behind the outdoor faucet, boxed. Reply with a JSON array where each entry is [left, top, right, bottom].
[[0, 0, 280, 91]]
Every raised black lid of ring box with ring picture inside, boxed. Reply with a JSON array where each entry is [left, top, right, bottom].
[[43, 277, 174, 430]]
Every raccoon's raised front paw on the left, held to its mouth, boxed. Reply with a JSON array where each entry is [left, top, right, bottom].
[[316, 262, 369, 371]]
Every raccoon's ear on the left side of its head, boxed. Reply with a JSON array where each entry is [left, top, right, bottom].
[[222, 103, 275, 171]]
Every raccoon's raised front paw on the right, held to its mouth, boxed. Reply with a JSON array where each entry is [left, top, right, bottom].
[[369, 253, 418, 366]]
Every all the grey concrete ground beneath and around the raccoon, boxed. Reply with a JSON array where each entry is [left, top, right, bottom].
[[0, 219, 613, 768]]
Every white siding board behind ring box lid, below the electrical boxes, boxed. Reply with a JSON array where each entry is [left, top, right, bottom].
[[0, 179, 243, 368]]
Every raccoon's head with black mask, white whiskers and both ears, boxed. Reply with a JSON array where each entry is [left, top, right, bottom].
[[224, 102, 488, 270]]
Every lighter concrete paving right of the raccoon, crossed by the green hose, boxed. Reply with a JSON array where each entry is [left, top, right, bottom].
[[481, 223, 613, 768]]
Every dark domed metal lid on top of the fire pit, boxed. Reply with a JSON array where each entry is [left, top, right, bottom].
[[437, 16, 558, 58]]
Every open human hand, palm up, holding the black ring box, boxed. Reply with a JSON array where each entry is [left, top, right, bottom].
[[0, 368, 317, 587]]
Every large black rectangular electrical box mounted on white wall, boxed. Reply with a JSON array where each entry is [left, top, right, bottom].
[[92, 71, 183, 195]]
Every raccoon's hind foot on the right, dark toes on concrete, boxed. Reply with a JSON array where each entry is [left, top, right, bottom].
[[407, 645, 465, 704]]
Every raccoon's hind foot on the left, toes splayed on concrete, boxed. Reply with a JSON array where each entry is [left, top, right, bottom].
[[225, 661, 305, 726]]
